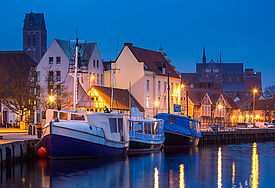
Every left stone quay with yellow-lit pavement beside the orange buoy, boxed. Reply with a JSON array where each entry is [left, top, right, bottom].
[[0, 128, 40, 167]]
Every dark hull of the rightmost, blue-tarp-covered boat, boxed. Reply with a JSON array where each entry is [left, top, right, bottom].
[[164, 131, 200, 149]]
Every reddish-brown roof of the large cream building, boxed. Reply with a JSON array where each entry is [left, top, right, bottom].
[[124, 45, 179, 78]]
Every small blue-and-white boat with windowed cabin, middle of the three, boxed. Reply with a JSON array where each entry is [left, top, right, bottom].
[[128, 118, 165, 154]]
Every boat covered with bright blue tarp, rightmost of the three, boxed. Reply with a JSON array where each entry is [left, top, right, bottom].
[[156, 113, 201, 149]]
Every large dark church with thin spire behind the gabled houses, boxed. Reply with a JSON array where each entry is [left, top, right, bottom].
[[181, 49, 262, 99]]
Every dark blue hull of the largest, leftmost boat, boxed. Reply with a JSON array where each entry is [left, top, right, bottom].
[[43, 134, 127, 159]]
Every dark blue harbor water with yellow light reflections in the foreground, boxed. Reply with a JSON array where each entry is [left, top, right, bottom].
[[0, 142, 275, 188]]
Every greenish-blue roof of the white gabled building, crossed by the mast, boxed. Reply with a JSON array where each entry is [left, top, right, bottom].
[[55, 39, 96, 61]]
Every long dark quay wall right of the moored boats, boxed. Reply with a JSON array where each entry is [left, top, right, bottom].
[[199, 128, 275, 146]]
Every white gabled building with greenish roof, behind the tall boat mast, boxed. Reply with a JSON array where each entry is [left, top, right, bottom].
[[36, 39, 104, 118]]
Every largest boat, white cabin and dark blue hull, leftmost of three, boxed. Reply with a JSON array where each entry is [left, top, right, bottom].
[[42, 109, 129, 159]]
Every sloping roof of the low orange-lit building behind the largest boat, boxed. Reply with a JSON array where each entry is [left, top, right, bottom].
[[92, 86, 147, 112]]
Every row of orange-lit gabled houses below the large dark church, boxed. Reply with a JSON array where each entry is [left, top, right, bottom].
[[181, 83, 236, 127]]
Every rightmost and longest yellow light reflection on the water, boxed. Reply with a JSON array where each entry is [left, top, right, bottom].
[[250, 143, 259, 188]]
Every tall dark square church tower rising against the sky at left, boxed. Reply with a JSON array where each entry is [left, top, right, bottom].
[[23, 12, 47, 63]]
